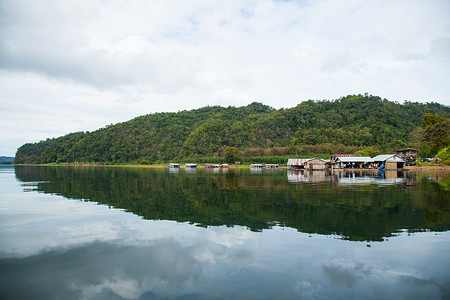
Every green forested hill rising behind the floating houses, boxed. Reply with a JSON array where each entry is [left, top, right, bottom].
[[15, 95, 450, 164]]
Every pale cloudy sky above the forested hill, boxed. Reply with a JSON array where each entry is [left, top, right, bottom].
[[0, 0, 450, 156]]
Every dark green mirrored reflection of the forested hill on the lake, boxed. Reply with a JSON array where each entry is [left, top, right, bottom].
[[15, 166, 450, 241]]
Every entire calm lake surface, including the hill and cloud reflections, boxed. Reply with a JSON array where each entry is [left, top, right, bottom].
[[0, 166, 450, 299]]
